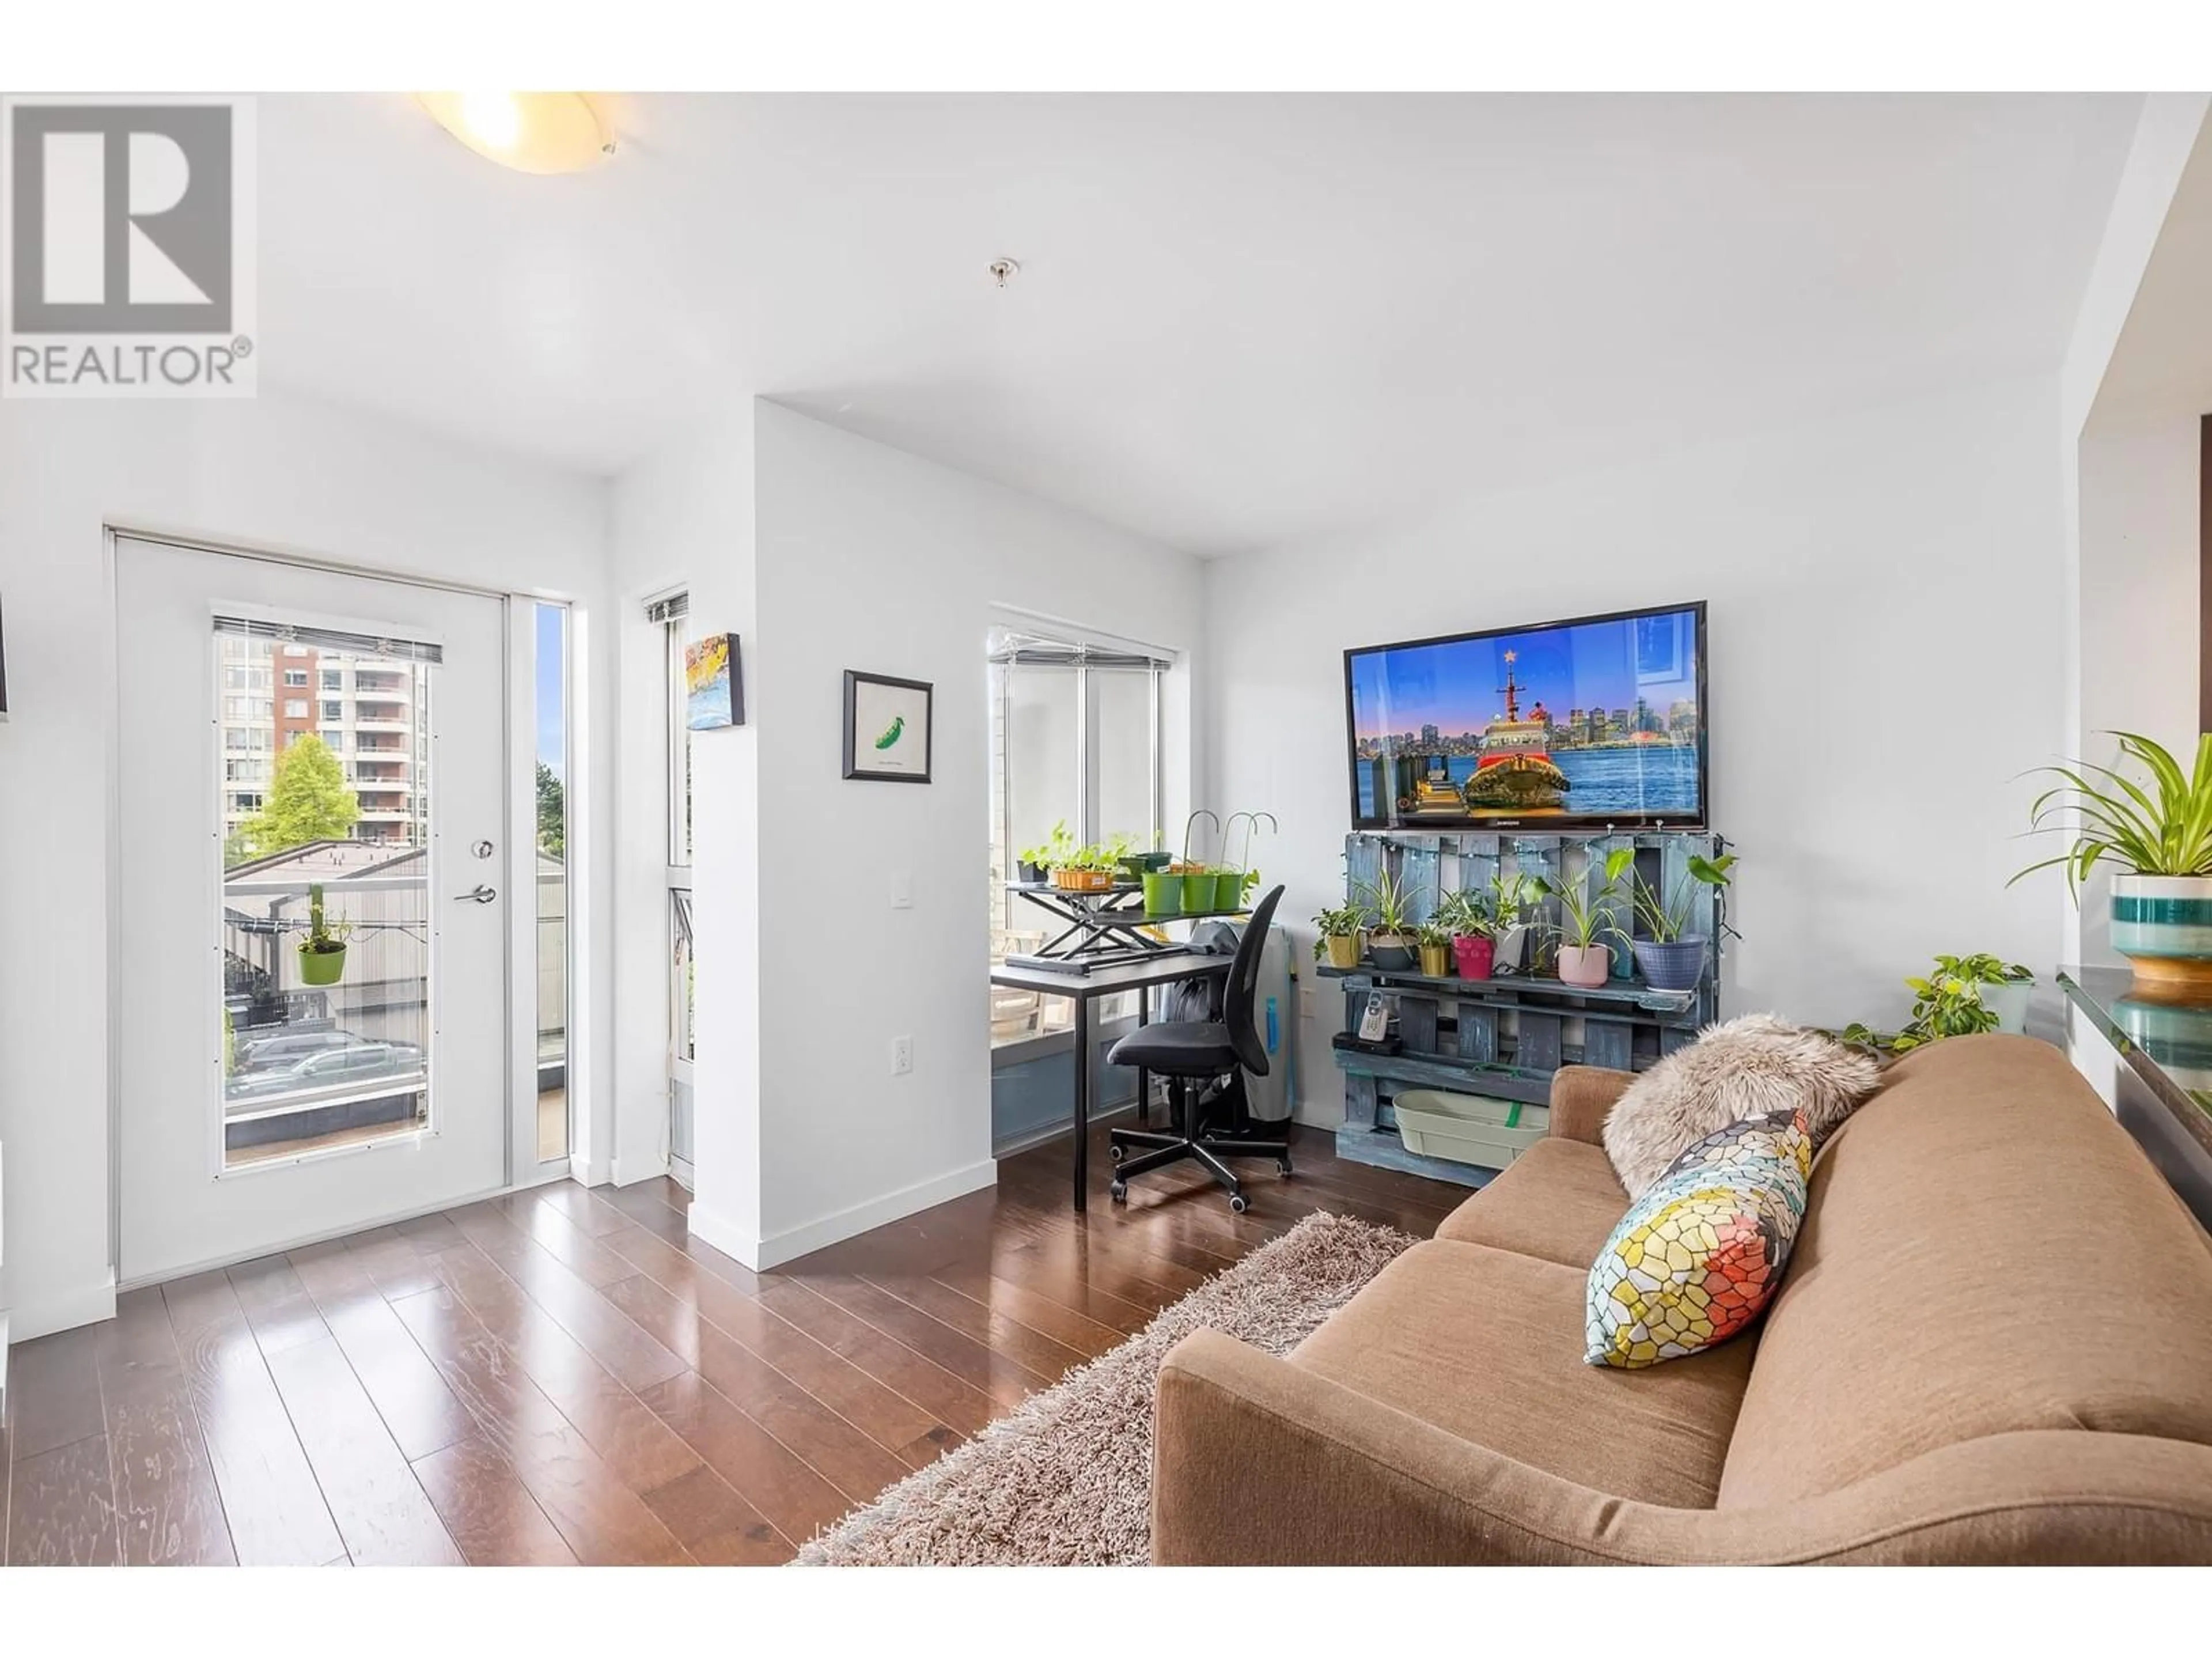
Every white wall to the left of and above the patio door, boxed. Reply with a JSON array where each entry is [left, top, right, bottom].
[[0, 396, 613, 1340]]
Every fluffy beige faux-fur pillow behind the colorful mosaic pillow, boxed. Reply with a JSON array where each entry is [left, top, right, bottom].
[[1606, 1013, 1883, 1199]]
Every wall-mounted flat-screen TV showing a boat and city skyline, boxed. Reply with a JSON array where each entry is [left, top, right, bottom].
[[1345, 601, 1707, 830]]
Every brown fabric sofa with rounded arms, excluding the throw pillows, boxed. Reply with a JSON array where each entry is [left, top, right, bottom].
[[1153, 1035, 2212, 1564]]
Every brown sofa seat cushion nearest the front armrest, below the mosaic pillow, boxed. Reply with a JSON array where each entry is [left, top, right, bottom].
[[1290, 1238, 1752, 1509]]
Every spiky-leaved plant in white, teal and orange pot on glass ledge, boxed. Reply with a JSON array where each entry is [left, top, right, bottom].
[[2006, 732, 2212, 993]]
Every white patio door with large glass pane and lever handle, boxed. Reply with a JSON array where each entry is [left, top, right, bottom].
[[113, 535, 511, 1281]]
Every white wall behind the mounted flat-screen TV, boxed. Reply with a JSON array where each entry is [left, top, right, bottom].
[[1206, 376, 2062, 1124]]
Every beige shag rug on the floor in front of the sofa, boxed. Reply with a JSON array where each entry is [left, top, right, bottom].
[[796, 1212, 1418, 1566]]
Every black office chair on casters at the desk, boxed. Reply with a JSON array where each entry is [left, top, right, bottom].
[[1106, 887, 1290, 1214]]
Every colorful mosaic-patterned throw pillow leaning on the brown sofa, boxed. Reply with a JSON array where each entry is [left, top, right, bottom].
[[1584, 1111, 1812, 1369]]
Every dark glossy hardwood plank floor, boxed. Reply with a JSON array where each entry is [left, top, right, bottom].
[[0, 1130, 1464, 1566]]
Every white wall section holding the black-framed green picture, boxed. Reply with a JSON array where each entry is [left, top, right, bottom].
[[721, 403, 1201, 1265]]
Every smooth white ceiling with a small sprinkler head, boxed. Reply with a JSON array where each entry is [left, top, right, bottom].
[[259, 95, 2139, 553]]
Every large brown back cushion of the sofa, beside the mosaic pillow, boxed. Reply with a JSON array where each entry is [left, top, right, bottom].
[[1716, 1035, 2212, 1509]]
